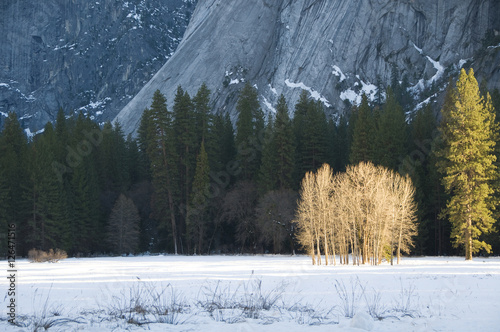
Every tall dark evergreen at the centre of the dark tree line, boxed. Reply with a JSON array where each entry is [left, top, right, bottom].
[[235, 82, 264, 180]]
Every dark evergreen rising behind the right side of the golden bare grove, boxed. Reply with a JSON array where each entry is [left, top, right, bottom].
[[375, 87, 407, 170]]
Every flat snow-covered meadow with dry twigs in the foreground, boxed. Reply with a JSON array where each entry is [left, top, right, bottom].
[[0, 256, 500, 332]]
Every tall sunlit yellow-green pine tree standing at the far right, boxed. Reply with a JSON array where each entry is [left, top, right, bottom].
[[438, 69, 496, 260]]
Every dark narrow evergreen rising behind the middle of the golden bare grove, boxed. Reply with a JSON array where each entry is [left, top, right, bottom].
[[349, 94, 375, 165]]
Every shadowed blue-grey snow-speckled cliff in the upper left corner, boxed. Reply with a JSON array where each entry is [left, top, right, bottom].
[[0, 0, 196, 131]]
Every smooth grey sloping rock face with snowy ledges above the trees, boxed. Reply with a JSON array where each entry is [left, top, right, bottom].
[[116, 0, 500, 136]]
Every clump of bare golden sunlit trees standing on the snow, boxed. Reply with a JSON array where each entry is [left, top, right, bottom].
[[295, 162, 417, 265]]
